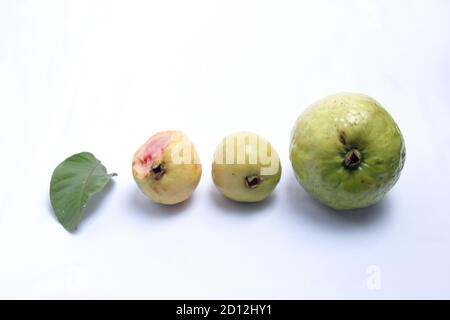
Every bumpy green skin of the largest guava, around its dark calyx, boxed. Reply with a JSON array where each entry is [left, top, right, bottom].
[[290, 93, 406, 210]]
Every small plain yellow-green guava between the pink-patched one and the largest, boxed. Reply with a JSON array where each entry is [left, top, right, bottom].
[[211, 132, 281, 202]]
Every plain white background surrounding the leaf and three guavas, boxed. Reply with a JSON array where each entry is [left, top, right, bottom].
[[0, 0, 450, 299]]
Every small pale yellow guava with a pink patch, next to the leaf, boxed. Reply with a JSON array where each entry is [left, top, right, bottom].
[[132, 131, 202, 204]]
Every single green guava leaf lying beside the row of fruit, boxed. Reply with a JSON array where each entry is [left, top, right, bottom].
[[50, 152, 116, 231]]
